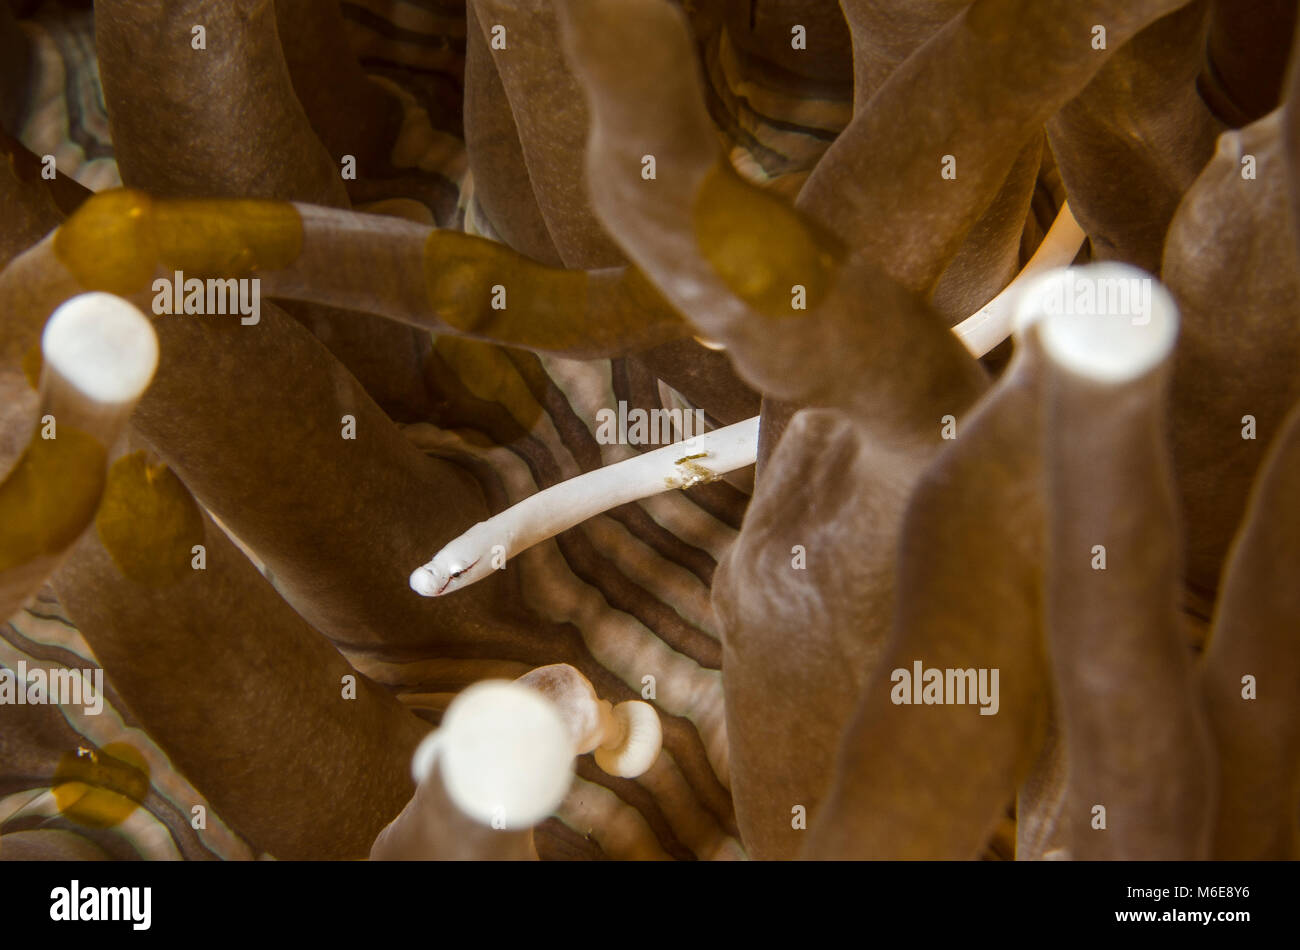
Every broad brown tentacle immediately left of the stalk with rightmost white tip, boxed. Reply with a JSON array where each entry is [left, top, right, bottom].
[[803, 342, 1049, 859]]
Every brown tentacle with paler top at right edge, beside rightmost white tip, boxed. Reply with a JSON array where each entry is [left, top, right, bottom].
[[1164, 112, 1300, 593]]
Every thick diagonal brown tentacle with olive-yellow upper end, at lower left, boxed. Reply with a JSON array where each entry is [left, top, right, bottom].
[[55, 451, 425, 859]]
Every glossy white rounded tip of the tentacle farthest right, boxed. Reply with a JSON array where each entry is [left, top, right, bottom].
[[1015, 263, 1178, 383]]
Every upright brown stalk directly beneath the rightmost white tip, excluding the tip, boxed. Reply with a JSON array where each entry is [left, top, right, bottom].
[[1044, 295, 1214, 860]]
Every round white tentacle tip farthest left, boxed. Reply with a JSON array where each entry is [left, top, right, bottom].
[[40, 292, 159, 405]]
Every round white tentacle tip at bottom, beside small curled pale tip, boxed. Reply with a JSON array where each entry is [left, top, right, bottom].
[[438, 680, 573, 829]]
